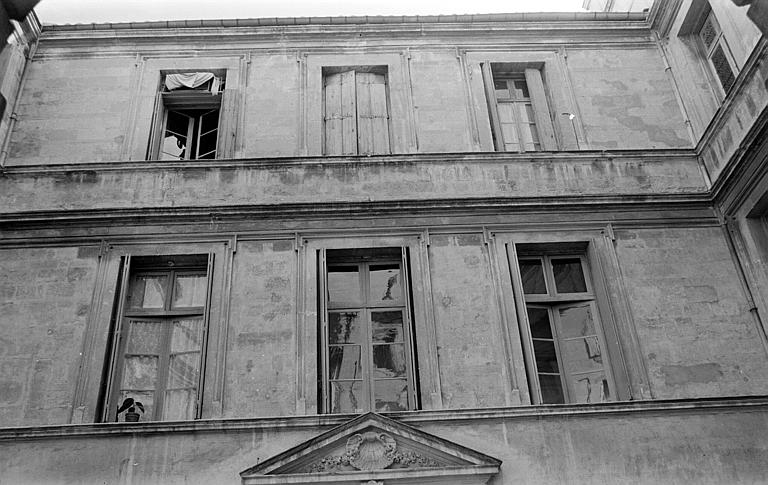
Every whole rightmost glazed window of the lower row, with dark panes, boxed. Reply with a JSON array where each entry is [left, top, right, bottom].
[[518, 254, 614, 404]]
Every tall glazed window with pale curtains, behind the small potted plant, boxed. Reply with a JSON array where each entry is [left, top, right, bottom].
[[108, 258, 208, 421]]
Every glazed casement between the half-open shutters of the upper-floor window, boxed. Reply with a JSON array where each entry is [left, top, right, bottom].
[[493, 72, 541, 152]]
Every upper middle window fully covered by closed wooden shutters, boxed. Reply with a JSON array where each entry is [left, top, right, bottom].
[[323, 66, 390, 155]]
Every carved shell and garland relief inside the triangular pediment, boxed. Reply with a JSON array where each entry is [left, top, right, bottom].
[[308, 431, 440, 473]]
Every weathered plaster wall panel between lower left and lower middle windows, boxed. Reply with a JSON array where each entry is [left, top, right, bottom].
[[223, 240, 296, 417]]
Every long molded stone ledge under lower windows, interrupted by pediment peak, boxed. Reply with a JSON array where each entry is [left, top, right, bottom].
[[0, 396, 768, 441]]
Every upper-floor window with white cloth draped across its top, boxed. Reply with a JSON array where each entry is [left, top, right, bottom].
[[153, 72, 223, 160]]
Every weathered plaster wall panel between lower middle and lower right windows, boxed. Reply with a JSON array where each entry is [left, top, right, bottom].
[[428, 234, 506, 408]]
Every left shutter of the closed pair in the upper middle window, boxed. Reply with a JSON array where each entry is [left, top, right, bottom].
[[324, 71, 357, 155]]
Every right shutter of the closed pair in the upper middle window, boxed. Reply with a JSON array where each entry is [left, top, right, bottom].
[[356, 72, 390, 155]]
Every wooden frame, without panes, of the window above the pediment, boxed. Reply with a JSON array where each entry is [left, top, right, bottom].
[[318, 247, 419, 414]]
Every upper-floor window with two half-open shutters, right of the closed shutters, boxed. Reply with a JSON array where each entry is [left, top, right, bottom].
[[482, 62, 557, 152]]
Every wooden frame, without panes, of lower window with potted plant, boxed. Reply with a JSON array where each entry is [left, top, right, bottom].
[[102, 254, 213, 422]]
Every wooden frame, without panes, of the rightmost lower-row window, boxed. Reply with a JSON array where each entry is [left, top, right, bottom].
[[515, 251, 621, 404]]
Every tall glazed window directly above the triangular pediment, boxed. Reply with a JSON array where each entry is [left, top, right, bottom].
[[323, 248, 416, 413]]
